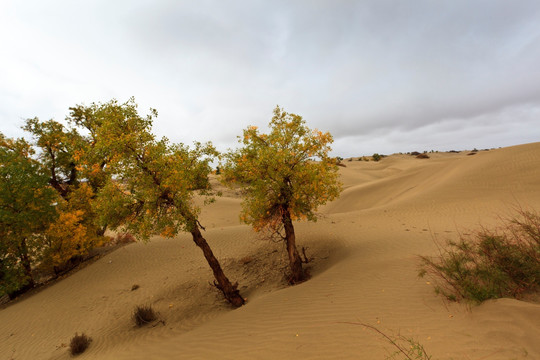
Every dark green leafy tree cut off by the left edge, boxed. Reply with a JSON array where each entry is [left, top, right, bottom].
[[0, 134, 57, 294]]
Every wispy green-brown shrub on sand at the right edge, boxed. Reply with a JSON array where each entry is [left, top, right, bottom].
[[419, 210, 540, 303]]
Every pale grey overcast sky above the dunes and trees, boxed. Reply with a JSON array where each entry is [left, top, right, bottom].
[[0, 0, 540, 157]]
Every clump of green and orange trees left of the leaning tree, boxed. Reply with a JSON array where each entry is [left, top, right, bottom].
[[0, 106, 129, 297]]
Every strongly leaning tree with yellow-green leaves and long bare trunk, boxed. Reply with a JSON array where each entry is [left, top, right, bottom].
[[94, 99, 244, 307]]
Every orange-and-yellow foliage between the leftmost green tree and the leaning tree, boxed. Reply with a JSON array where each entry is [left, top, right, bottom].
[[17, 105, 114, 284]]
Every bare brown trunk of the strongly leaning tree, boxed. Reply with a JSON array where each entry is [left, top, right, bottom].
[[191, 224, 245, 307]]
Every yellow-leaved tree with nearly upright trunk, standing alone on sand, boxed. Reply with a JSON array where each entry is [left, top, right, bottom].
[[221, 106, 341, 284]]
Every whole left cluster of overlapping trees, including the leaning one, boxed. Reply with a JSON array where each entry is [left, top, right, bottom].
[[0, 99, 244, 306]]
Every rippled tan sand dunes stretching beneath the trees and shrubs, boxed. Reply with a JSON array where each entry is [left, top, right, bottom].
[[0, 143, 540, 360]]
